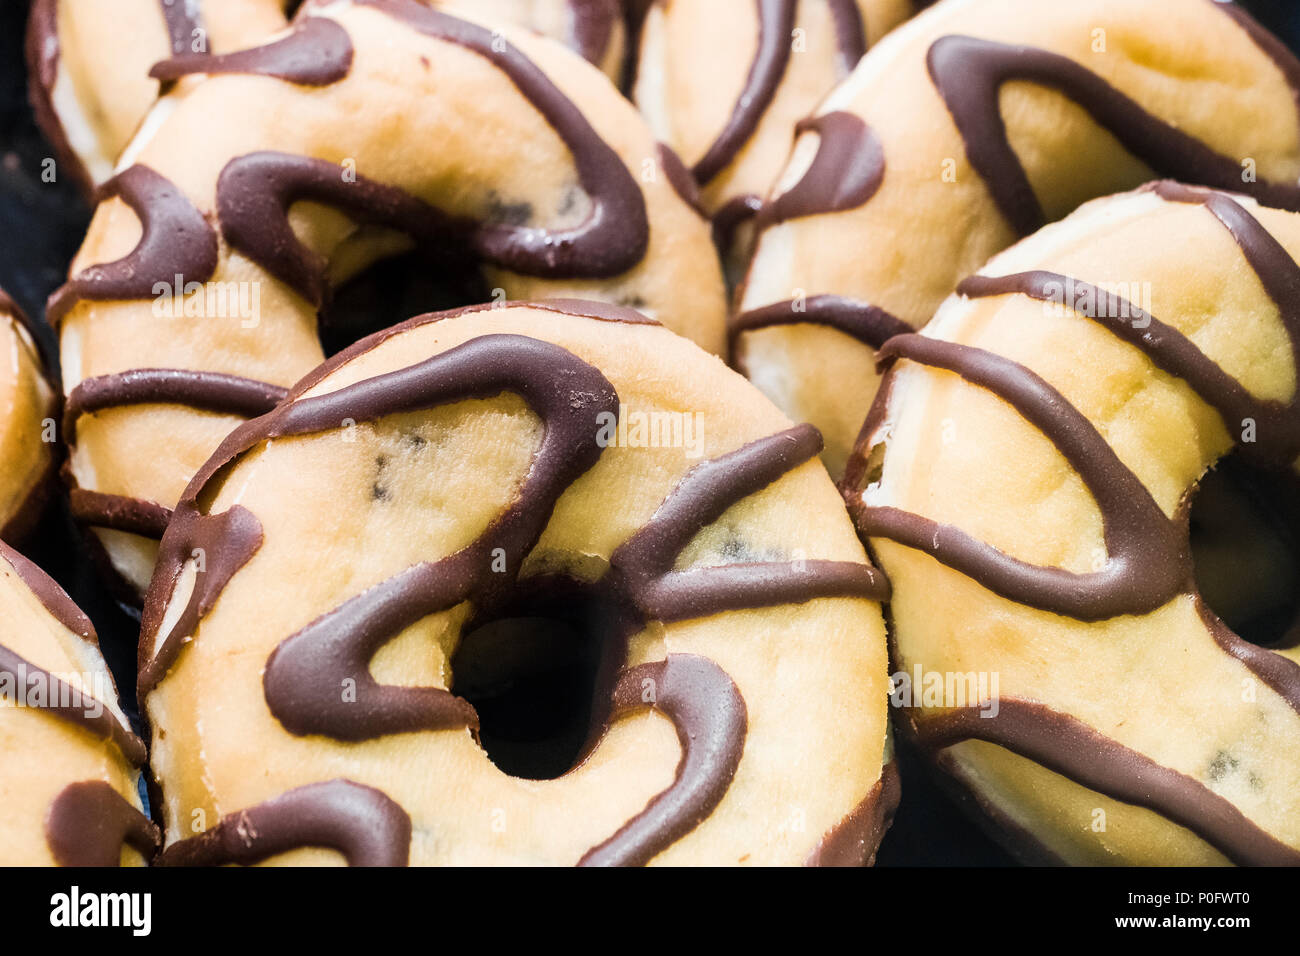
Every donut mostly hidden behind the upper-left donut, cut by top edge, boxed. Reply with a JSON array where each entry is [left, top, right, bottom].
[[26, 0, 625, 191]]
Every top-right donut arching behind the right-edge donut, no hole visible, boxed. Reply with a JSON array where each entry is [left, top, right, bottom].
[[732, 0, 1300, 475]]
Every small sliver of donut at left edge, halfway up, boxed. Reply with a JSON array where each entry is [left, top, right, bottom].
[[0, 289, 57, 542]]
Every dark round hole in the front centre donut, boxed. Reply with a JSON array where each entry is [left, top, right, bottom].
[[451, 588, 624, 780]]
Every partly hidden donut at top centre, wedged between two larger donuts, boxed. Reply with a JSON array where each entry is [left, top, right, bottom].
[[633, 0, 920, 274]]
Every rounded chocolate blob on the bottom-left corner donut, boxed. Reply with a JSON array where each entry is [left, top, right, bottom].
[[46, 780, 160, 866]]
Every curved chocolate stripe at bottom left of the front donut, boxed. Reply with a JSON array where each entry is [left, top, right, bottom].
[[159, 779, 411, 866]]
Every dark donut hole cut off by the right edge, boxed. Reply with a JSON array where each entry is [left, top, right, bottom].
[[1188, 455, 1300, 649]]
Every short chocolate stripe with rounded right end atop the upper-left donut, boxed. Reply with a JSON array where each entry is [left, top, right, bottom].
[[150, 17, 354, 86]]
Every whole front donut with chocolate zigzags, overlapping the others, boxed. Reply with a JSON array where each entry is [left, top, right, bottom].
[[138, 302, 897, 865]]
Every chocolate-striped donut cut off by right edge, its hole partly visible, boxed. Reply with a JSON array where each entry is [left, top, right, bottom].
[[844, 182, 1300, 865]]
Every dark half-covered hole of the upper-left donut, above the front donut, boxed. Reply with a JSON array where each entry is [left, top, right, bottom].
[[317, 251, 491, 358]]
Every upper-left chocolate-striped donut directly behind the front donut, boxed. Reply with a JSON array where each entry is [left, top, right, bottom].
[[49, 0, 725, 592]]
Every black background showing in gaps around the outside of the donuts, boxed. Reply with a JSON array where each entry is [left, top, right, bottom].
[[0, 0, 1300, 866]]
